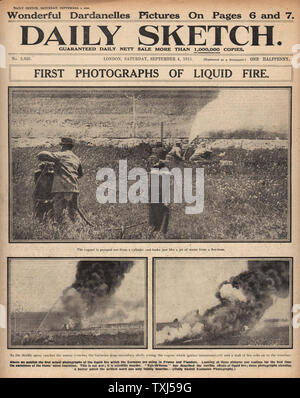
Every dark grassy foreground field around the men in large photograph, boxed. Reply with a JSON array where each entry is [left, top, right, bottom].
[[11, 142, 289, 241]]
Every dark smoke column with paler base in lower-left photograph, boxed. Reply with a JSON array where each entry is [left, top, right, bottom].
[[61, 260, 133, 327]]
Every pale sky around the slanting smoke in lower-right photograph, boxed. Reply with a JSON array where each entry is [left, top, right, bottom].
[[155, 259, 289, 322]]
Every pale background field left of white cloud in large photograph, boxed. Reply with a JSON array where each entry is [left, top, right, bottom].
[[10, 88, 213, 140]]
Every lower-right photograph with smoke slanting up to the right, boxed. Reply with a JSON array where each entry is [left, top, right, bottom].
[[153, 257, 293, 349]]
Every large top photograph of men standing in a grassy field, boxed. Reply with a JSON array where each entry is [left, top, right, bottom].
[[8, 87, 291, 242]]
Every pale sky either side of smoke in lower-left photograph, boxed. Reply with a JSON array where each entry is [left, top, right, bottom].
[[9, 258, 145, 312]]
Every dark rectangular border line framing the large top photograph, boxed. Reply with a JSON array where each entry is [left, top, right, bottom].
[[8, 86, 293, 244]]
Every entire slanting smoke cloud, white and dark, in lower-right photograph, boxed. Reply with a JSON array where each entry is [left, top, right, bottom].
[[157, 260, 289, 344]]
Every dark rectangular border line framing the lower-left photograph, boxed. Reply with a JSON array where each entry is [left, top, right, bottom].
[[6, 257, 149, 350]]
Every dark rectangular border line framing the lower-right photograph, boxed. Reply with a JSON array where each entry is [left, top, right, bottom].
[[152, 256, 294, 350]]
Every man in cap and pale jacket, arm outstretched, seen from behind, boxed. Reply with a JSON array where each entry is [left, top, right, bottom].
[[38, 137, 83, 223]]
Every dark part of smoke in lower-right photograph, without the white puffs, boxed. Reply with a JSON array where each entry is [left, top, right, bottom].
[[203, 260, 289, 335]]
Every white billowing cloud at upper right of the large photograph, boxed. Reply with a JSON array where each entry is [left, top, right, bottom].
[[190, 89, 289, 141]]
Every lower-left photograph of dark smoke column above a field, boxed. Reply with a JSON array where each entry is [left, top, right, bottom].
[[8, 258, 147, 348]]
